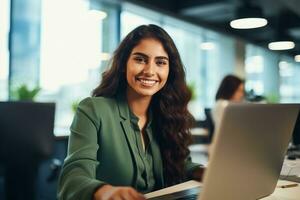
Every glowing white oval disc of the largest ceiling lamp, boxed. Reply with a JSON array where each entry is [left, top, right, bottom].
[[230, 17, 268, 29]]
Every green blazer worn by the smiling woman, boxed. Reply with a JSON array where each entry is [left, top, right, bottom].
[[58, 94, 199, 200]]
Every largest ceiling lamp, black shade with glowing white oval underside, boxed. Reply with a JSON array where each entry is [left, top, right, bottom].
[[230, 3, 268, 29]]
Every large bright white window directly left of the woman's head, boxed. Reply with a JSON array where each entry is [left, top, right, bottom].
[[39, 0, 117, 135]]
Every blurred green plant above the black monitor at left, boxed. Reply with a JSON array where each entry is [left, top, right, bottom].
[[14, 84, 41, 101]]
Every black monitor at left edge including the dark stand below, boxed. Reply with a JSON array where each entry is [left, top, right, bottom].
[[0, 101, 55, 200]]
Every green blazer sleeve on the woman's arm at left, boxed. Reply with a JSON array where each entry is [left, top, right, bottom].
[[58, 98, 105, 200]]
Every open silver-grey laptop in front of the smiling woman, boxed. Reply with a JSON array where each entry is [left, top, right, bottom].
[[145, 103, 300, 200]]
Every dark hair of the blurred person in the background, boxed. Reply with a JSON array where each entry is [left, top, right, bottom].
[[216, 75, 244, 100]]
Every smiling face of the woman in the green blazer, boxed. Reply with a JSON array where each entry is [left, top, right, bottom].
[[126, 38, 169, 97]]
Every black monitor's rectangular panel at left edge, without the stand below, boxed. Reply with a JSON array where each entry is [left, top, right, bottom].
[[0, 101, 55, 163]]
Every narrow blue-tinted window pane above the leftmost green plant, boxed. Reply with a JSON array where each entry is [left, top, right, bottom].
[[9, 0, 41, 96]]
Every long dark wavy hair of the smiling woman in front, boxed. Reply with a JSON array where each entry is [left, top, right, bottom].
[[92, 24, 194, 185]]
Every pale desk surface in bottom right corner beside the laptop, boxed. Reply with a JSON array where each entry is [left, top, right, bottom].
[[262, 180, 300, 200]]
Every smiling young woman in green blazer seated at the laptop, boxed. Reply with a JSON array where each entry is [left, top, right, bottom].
[[58, 25, 203, 200]]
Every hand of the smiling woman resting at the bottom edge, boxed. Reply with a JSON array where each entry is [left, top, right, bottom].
[[94, 185, 146, 200]]
